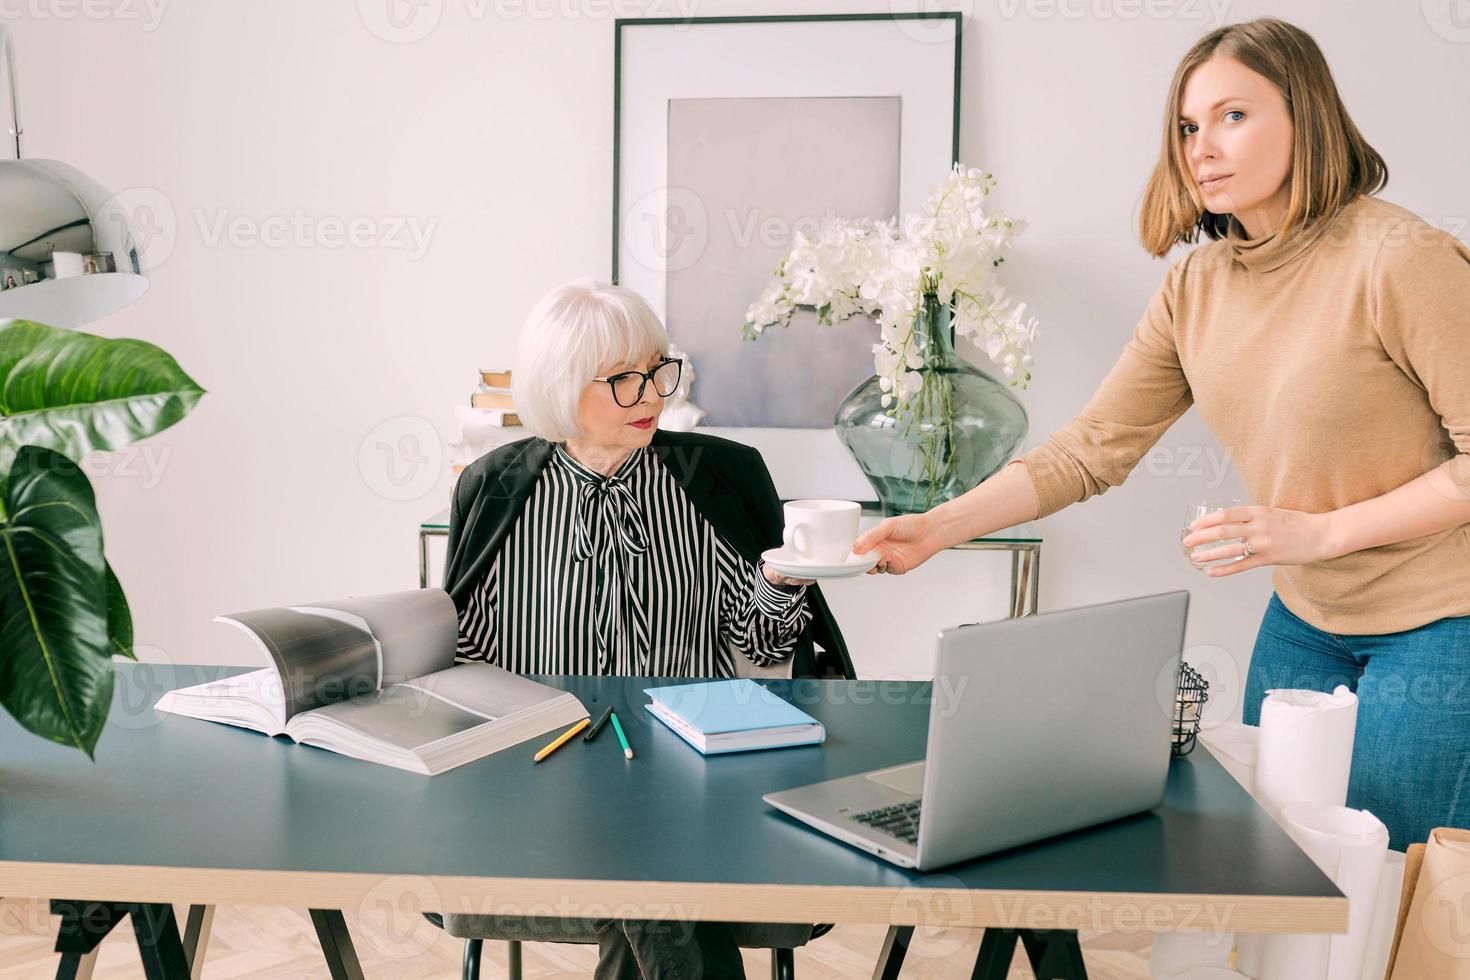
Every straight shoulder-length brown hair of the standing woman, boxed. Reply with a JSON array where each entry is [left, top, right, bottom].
[[1138, 18, 1388, 256]]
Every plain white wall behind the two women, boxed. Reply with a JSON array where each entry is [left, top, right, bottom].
[[17, 0, 1470, 719]]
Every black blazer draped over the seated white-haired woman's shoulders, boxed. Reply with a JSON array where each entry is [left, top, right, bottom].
[[444, 429, 856, 677]]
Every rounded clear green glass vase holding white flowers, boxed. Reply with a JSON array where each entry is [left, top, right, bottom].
[[833, 294, 1028, 516]]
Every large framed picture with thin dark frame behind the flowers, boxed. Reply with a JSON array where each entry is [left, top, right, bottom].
[[613, 12, 961, 500]]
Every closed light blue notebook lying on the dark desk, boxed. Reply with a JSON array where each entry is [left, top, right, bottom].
[[644, 677, 826, 755]]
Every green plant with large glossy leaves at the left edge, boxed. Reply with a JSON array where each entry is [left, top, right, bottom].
[[0, 320, 204, 758]]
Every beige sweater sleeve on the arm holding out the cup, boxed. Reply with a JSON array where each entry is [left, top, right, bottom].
[[1022, 253, 1193, 517]]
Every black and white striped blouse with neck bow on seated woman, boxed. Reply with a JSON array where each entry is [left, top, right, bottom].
[[456, 445, 811, 677]]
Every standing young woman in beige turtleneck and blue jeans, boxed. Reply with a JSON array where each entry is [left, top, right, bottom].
[[857, 19, 1470, 849]]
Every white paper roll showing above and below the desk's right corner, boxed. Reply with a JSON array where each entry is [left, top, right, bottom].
[[1263, 804, 1388, 980]]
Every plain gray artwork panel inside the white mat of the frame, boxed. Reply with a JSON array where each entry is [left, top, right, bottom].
[[664, 96, 900, 429]]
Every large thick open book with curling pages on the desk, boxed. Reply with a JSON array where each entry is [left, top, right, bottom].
[[156, 589, 587, 776]]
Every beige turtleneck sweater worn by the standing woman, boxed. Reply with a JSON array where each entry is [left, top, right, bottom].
[[1022, 197, 1470, 635]]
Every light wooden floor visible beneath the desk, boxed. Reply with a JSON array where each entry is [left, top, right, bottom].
[[0, 899, 1151, 980]]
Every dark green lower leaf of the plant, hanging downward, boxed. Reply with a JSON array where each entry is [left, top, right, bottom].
[[0, 445, 113, 757]]
